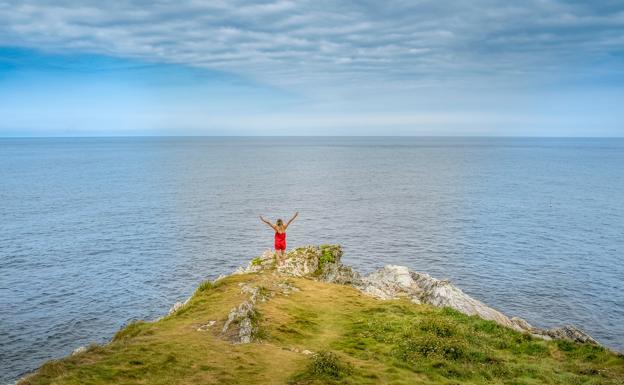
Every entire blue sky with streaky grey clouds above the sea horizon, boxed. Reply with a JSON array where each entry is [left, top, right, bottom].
[[0, 0, 624, 137]]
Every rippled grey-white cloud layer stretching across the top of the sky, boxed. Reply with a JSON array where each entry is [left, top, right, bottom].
[[0, 0, 624, 88]]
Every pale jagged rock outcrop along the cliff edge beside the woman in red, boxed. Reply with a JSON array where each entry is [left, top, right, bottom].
[[234, 245, 598, 345]]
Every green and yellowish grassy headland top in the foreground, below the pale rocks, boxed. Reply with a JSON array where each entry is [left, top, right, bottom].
[[19, 246, 624, 385]]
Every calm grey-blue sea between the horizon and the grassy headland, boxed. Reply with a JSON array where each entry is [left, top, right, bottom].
[[0, 138, 624, 384]]
